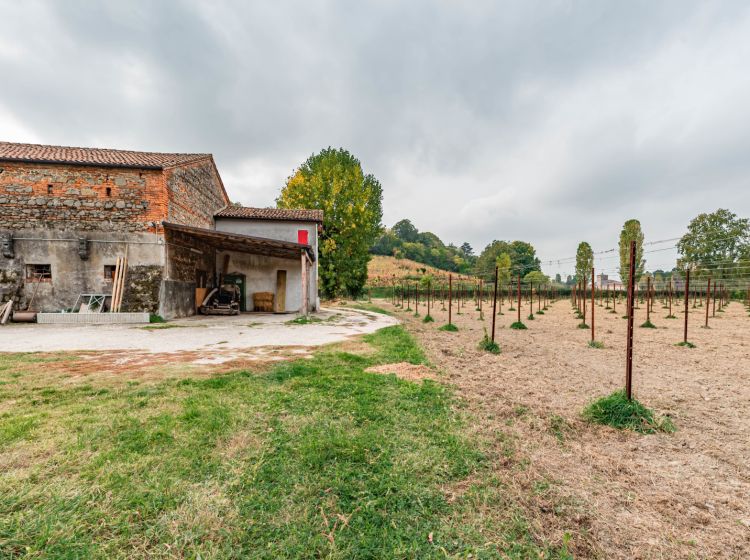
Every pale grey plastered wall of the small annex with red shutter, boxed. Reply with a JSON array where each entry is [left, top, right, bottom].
[[216, 218, 320, 311]]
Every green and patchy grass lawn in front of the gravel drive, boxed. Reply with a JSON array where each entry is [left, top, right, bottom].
[[0, 326, 567, 559]]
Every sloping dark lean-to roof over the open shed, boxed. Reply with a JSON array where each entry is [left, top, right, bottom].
[[162, 222, 315, 261]]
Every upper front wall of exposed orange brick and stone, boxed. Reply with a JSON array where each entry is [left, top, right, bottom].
[[0, 162, 166, 232]]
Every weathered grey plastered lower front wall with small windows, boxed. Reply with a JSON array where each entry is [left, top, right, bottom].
[[0, 229, 164, 312]]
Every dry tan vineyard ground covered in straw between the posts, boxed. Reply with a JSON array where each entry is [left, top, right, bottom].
[[379, 300, 750, 558]]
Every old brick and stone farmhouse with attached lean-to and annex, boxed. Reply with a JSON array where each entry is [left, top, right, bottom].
[[0, 142, 323, 318]]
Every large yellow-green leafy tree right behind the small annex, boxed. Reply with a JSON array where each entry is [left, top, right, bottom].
[[276, 148, 383, 297]]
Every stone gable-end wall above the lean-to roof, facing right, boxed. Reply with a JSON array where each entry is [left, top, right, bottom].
[[164, 160, 229, 229]]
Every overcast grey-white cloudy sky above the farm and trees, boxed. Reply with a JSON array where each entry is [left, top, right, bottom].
[[0, 0, 750, 274]]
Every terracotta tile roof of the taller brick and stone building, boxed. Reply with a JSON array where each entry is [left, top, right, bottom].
[[0, 142, 211, 169]]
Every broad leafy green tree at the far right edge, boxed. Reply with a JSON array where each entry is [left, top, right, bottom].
[[677, 208, 750, 280]]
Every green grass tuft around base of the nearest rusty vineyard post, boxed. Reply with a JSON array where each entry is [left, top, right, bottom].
[[583, 390, 675, 434]]
